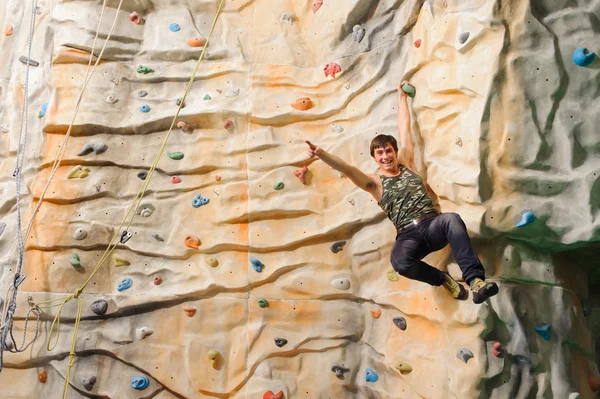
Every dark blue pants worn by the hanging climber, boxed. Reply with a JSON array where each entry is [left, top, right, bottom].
[[391, 213, 485, 286]]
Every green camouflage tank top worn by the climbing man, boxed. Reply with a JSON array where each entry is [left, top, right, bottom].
[[377, 165, 436, 229]]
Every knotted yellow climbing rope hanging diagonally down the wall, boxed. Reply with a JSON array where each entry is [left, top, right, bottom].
[[37, 0, 225, 399]]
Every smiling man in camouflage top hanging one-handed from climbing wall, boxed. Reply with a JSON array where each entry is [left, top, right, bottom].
[[306, 81, 498, 304]]
